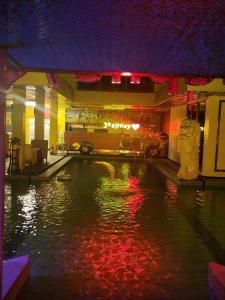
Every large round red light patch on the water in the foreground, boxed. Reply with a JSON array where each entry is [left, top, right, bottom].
[[64, 228, 171, 299]]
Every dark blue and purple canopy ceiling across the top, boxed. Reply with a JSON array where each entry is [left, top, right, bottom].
[[0, 0, 225, 77]]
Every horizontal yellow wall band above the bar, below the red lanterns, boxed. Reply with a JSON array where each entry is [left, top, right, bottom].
[[74, 90, 155, 105]]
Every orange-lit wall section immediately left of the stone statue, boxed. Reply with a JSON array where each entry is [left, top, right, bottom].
[[168, 105, 187, 163]]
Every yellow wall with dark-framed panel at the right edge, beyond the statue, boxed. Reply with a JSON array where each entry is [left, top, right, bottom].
[[202, 96, 225, 177]]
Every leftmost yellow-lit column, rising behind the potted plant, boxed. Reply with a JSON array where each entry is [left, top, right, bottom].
[[12, 86, 26, 170]]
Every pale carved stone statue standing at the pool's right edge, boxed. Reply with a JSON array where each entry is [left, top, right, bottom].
[[177, 119, 201, 180]]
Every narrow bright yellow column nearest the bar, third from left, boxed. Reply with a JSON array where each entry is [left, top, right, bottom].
[[50, 90, 58, 154]]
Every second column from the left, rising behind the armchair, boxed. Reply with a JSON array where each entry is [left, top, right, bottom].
[[34, 86, 45, 140]]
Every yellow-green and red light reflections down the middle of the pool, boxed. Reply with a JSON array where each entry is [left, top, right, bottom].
[[64, 166, 159, 299]]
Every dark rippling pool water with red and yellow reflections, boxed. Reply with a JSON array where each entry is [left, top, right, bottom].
[[4, 160, 225, 300]]
